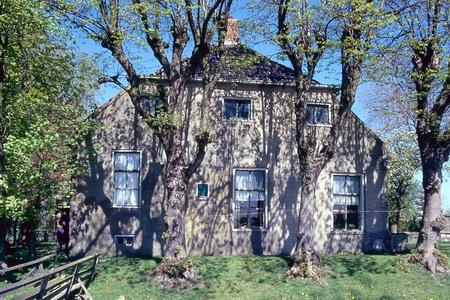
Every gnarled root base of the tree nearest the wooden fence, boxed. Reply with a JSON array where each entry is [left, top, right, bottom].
[[151, 258, 201, 289]]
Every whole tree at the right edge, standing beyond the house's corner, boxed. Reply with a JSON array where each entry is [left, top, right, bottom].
[[370, 0, 450, 272]]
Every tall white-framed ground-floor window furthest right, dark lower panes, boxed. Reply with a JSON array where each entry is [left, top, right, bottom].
[[333, 175, 361, 229]]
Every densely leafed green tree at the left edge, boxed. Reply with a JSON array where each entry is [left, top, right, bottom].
[[0, 0, 96, 261]]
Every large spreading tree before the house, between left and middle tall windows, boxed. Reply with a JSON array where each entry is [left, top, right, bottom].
[[48, 0, 232, 283]]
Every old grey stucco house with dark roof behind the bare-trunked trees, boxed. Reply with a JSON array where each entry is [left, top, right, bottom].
[[70, 23, 388, 256]]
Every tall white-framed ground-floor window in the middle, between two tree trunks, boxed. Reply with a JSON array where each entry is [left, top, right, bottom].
[[233, 170, 266, 228]]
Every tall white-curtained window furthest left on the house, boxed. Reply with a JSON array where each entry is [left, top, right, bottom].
[[113, 152, 141, 206]]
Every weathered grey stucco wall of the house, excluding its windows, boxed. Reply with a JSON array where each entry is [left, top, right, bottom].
[[70, 74, 387, 256]]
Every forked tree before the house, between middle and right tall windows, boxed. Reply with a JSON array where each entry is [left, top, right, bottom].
[[250, 0, 386, 278]]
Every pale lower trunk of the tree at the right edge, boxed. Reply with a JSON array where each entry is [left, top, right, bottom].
[[416, 163, 447, 273]]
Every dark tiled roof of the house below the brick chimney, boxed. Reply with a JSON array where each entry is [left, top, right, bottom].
[[151, 44, 319, 84]]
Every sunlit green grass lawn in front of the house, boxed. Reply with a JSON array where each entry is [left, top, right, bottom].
[[89, 251, 450, 299]]
